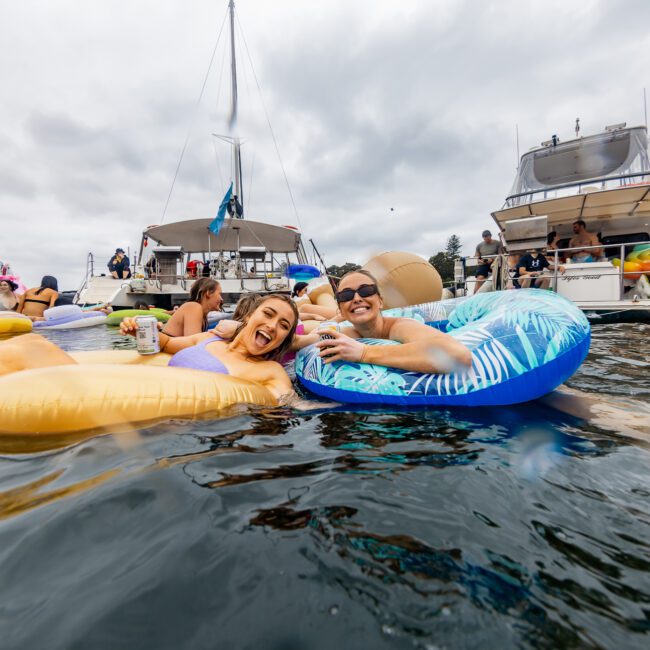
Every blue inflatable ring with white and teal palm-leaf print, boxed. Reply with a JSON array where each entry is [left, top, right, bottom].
[[296, 289, 591, 406]]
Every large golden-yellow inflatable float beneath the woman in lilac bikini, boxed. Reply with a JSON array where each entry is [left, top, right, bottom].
[[0, 350, 276, 440]]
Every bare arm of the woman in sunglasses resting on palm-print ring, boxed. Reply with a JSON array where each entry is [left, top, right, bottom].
[[316, 318, 472, 373]]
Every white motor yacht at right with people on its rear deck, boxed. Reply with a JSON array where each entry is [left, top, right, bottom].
[[484, 121, 650, 322]]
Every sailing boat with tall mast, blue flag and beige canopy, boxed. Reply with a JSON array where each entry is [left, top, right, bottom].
[[76, 0, 324, 308]]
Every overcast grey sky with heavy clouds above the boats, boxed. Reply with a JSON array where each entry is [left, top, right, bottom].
[[0, 0, 650, 289]]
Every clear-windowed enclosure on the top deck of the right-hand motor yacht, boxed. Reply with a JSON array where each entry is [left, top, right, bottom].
[[508, 126, 650, 199]]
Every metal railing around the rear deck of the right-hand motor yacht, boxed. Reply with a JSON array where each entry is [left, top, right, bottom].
[[456, 240, 650, 300]]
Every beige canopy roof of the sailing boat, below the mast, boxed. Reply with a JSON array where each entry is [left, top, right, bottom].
[[143, 219, 300, 253]]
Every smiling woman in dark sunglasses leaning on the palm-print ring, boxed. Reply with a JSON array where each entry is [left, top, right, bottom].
[[294, 270, 472, 373]]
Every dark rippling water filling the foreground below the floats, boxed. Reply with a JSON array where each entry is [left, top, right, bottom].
[[0, 325, 650, 650]]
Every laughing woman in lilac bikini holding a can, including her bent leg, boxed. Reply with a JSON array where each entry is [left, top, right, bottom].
[[0, 294, 298, 404]]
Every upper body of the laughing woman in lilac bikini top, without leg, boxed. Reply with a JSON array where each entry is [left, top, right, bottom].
[[120, 294, 298, 403]]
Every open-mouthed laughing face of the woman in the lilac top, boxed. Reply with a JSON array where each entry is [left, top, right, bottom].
[[237, 298, 297, 356]]
